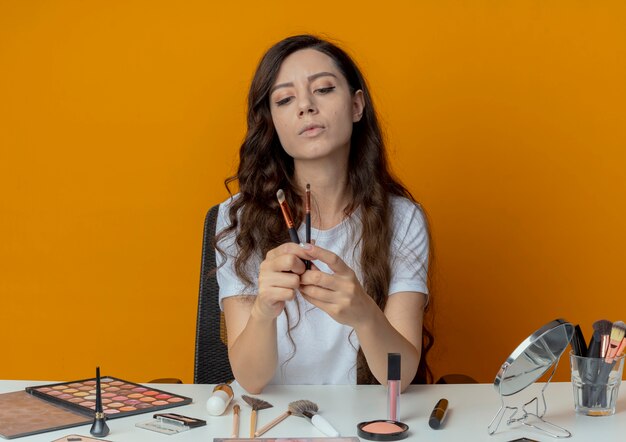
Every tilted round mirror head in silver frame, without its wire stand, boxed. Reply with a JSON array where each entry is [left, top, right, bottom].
[[493, 319, 574, 396]]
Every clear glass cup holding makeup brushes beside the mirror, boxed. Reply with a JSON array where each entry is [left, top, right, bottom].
[[570, 353, 624, 416]]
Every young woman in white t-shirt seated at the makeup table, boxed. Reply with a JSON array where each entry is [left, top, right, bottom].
[[216, 35, 429, 393]]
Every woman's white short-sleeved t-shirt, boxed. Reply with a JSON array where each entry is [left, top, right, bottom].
[[216, 196, 428, 385]]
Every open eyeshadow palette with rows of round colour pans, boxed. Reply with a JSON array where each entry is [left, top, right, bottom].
[[26, 376, 191, 419]]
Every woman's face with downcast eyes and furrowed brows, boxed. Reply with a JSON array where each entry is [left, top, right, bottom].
[[270, 49, 363, 165]]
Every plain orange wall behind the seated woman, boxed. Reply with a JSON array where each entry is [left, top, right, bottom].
[[0, 0, 626, 382]]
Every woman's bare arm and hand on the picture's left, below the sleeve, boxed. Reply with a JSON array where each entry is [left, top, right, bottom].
[[222, 243, 307, 394]]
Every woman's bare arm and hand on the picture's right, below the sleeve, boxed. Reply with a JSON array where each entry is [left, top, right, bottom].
[[300, 245, 426, 389]]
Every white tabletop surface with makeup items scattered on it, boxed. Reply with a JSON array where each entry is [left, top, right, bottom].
[[0, 381, 626, 442]]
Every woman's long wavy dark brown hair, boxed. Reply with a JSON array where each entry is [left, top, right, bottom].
[[216, 35, 434, 384]]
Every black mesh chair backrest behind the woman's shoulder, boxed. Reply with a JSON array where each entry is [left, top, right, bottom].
[[193, 205, 235, 384]]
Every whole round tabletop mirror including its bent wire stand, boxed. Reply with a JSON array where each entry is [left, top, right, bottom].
[[487, 319, 574, 438]]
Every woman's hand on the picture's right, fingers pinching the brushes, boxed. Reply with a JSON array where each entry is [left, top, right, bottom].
[[299, 245, 382, 329]]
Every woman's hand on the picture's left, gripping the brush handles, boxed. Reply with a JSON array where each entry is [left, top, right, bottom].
[[251, 243, 311, 320]]
